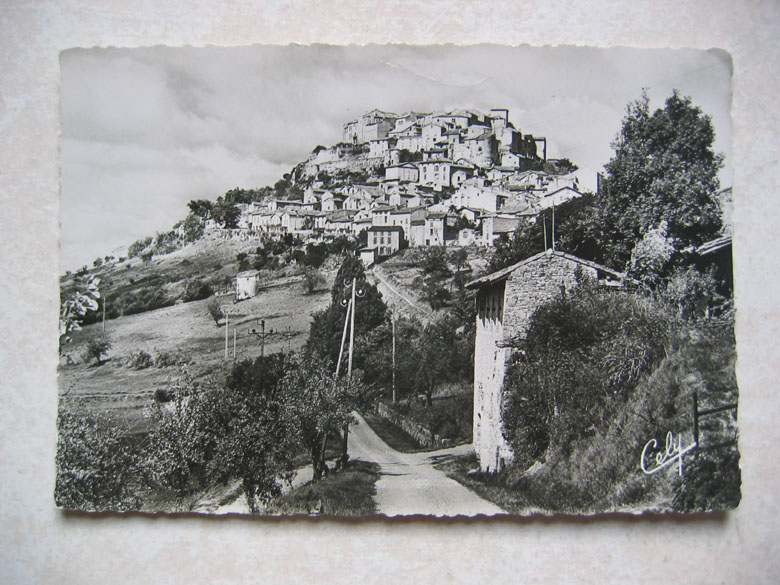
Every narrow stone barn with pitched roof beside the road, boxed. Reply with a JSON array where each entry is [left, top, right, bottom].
[[467, 250, 625, 472]]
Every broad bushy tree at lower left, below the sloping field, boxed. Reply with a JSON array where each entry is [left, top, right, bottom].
[[147, 354, 298, 512]]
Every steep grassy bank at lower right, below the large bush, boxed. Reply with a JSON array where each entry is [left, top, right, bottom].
[[438, 318, 740, 514]]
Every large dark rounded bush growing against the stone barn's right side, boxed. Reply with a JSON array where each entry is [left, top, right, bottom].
[[504, 282, 675, 465]]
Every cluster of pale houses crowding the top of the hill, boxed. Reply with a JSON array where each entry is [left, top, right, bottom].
[[206, 109, 595, 258]]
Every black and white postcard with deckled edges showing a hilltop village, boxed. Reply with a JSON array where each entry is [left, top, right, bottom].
[[54, 45, 740, 516]]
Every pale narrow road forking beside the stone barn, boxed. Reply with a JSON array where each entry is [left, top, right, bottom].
[[349, 415, 505, 516]]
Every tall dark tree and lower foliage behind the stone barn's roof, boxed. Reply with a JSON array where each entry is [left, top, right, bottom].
[[491, 91, 722, 270]]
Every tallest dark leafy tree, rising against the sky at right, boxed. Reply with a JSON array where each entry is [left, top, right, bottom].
[[597, 90, 723, 267]]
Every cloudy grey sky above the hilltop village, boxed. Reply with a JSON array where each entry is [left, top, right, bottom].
[[60, 45, 732, 271]]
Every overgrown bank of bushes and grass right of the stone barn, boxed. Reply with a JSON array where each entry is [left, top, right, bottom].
[[503, 282, 740, 511]]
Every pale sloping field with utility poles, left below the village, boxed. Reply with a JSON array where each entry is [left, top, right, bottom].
[[59, 271, 334, 432]]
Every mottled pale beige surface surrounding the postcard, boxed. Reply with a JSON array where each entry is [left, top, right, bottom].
[[0, 0, 780, 584]]
